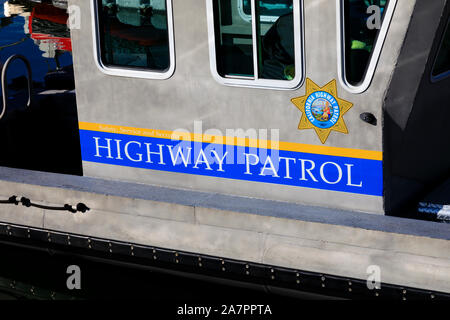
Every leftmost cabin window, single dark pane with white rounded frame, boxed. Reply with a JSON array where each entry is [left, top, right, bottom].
[[93, 0, 175, 79]]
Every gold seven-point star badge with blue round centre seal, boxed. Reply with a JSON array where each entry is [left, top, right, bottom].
[[291, 78, 353, 144]]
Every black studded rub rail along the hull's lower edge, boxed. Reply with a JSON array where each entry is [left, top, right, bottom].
[[0, 223, 450, 300]]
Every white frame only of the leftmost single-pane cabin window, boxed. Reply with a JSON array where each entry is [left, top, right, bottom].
[[90, 0, 176, 80]]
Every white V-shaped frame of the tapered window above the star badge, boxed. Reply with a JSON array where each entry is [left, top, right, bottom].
[[336, 0, 398, 94]]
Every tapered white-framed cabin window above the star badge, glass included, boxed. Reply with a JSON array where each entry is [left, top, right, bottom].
[[338, 0, 397, 93]]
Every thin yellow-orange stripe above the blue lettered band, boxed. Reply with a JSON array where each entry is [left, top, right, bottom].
[[79, 122, 383, 161]]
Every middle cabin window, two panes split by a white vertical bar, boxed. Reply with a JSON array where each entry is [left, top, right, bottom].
[[208, 0, 303, 89]]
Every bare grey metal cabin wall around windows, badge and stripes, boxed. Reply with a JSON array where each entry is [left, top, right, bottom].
[[72, 0, 415, 213]]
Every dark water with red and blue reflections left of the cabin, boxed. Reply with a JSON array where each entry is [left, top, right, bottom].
[[0, 0, 82, 175]]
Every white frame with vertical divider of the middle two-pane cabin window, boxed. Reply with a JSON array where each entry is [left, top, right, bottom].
[[206, 0, 305, 90]]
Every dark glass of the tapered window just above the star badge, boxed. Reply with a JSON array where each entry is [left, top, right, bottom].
[[344, 0, 388, 85]]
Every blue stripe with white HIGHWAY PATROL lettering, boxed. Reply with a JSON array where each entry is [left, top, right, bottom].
[[80, 130, 383, 196]]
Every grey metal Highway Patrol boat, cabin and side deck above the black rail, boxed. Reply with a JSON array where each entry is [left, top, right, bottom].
[[0, 0, 450, 299]]
